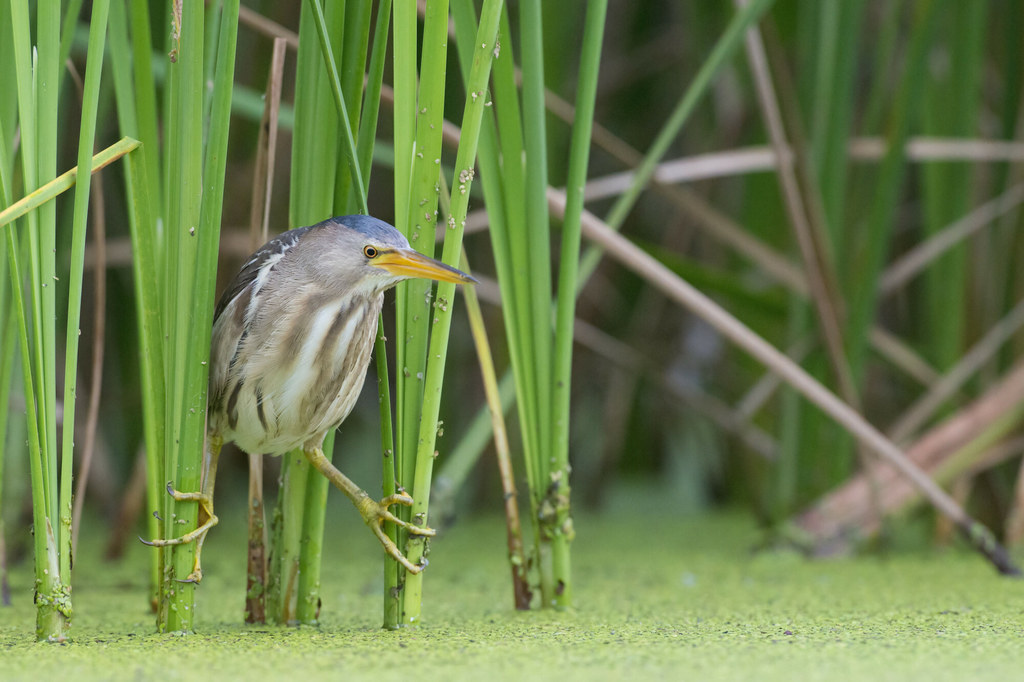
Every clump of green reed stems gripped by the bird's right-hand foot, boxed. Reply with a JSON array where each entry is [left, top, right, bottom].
[[384, 0, 502, 628]]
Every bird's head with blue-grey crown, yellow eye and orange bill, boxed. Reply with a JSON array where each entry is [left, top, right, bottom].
[[322, 215, 476, 293]]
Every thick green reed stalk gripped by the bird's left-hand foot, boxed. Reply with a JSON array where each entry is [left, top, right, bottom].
[[158, 0, 239, 631]]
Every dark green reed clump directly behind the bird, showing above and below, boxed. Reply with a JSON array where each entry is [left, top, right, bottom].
[[267, 0, 390, 624]]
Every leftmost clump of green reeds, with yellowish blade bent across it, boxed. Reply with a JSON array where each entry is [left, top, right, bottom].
[[0, 0, 109, 641]]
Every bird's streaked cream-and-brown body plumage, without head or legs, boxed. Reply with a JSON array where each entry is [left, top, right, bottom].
[[207, 215, 398, 455]]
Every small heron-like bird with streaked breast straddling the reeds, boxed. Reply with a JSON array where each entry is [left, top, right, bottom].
[[142, 215, 476, 583]]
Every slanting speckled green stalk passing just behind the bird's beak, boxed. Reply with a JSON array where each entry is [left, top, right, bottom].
[[402, 0, 503, 625]]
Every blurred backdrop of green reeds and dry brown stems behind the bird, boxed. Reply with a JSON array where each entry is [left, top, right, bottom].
[[6, 0, 1024, 585]]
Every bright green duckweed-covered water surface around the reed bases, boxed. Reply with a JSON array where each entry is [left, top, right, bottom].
[[0, 503, 1024, 682]]
